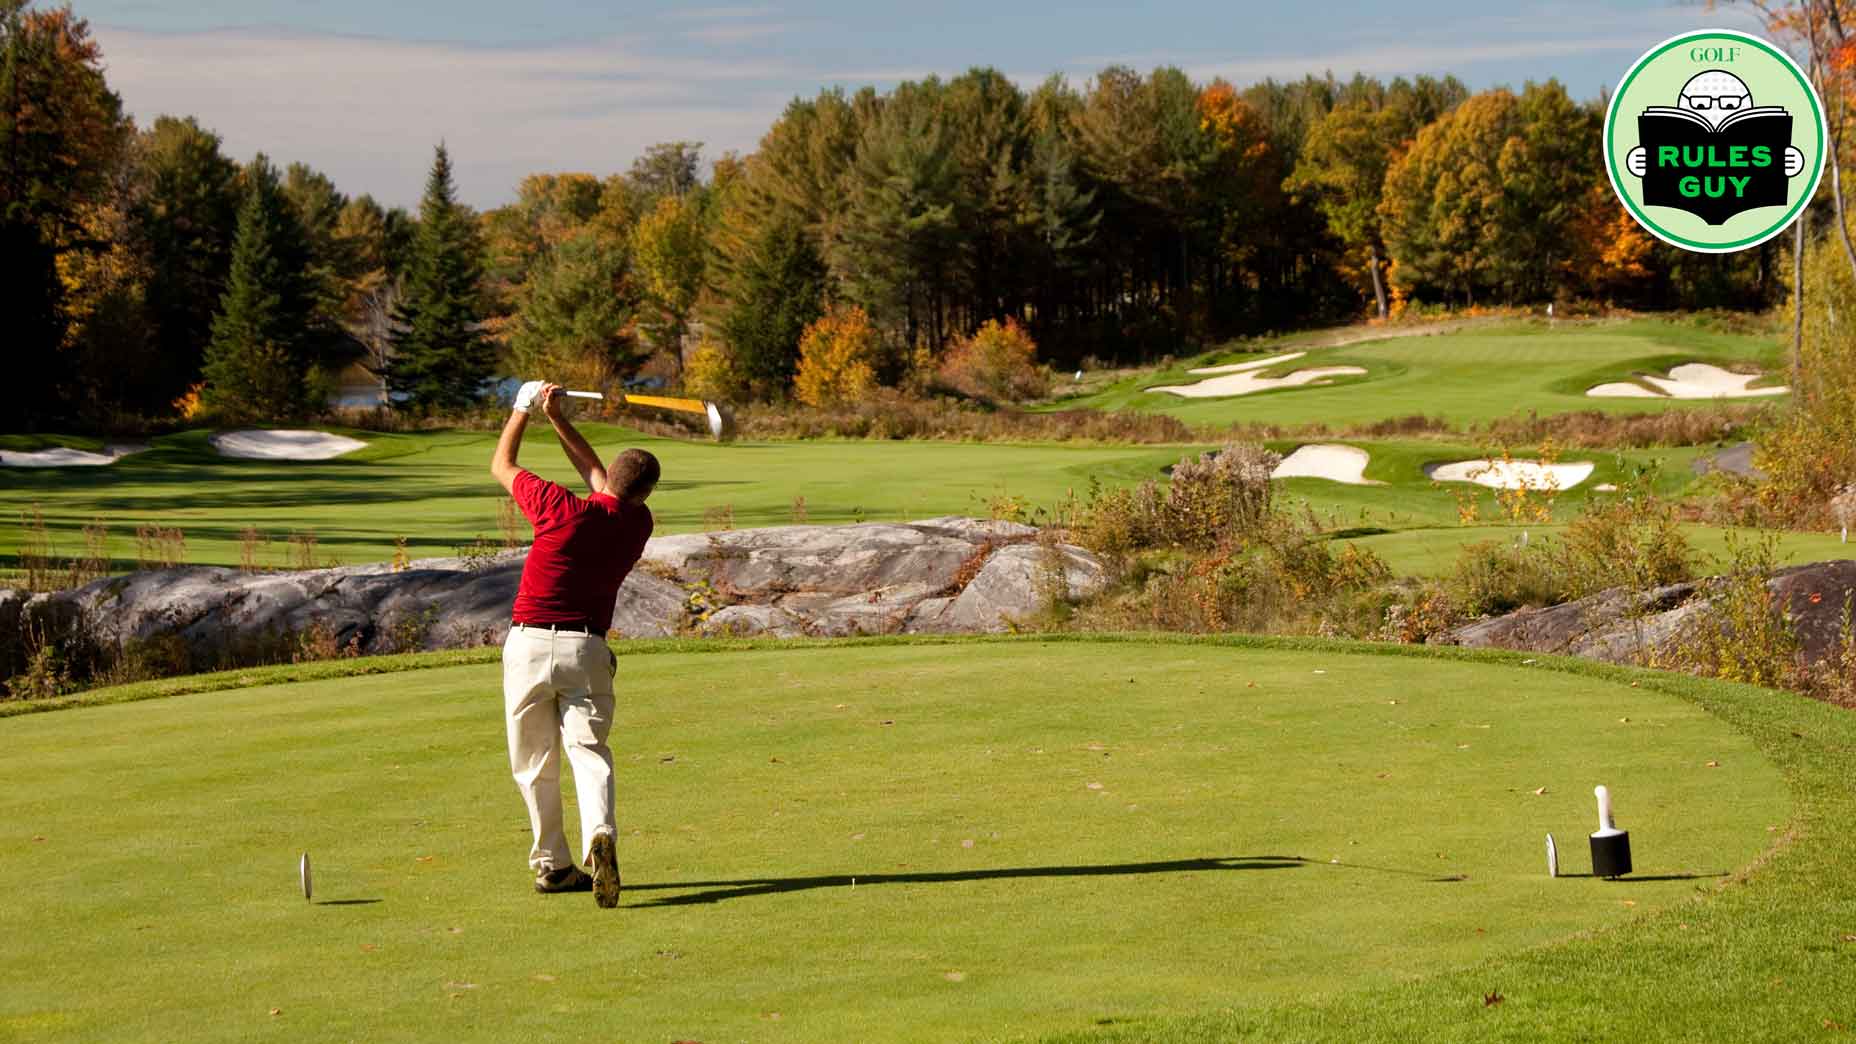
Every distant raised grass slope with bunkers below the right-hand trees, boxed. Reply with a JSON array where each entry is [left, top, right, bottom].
[[1056, 320, 1782, 425]]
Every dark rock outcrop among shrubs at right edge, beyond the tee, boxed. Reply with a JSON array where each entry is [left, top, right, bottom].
[[1444, 559, 1856, 663]]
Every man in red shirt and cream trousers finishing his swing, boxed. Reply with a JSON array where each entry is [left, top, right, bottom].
[[490, 381, 657, 907]]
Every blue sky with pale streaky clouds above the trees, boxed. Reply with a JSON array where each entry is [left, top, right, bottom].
[[71, 0, 1758, 208]]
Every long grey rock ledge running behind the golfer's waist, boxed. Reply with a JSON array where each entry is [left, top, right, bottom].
[[0, 518, 1102, 669]]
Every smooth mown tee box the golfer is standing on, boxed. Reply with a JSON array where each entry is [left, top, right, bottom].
[[0, 639, 1791, 1040]]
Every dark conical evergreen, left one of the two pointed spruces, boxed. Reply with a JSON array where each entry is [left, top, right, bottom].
[[202, 154, 314, 420]]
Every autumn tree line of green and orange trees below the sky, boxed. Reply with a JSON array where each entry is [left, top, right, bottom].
[[0, 0, 1785, 427]]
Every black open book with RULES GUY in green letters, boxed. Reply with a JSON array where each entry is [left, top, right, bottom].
[[1637, 106, 1791, 225]]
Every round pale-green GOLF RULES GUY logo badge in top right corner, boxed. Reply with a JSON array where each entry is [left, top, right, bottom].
[[1605, 30, 1826, 253]]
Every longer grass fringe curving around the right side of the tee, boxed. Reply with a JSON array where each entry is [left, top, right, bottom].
[[1024, 635, 1856, 1044]]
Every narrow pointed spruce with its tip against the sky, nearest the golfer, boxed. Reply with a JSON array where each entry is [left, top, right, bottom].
[[386, 145, 496, 412]]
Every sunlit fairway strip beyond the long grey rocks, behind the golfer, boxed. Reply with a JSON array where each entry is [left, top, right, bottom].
[[0, 424, 1184, 568]]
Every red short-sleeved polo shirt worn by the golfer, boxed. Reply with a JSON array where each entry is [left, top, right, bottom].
[[510, 472, 651, 633]]
